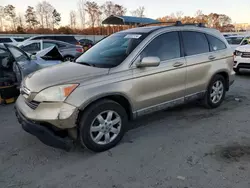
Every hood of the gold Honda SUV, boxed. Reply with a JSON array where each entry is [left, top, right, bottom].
[[24, 62, 109, 92]]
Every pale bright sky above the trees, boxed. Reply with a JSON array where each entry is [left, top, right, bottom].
[[0, 0, 250, 25]]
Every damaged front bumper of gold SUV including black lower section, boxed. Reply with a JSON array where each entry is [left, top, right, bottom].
[[15, 96, 78, 151]]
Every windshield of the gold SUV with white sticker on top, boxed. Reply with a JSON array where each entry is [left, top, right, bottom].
[[76, 33, 147, 68]]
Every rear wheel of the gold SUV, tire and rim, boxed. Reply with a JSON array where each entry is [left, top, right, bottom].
[[204, 75, 226, 108]]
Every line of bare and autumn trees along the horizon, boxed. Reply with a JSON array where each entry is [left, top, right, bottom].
[[0, 0, 238, 35]]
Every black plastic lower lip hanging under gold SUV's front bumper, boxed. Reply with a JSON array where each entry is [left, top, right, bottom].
[[15, 107, 74, 151]]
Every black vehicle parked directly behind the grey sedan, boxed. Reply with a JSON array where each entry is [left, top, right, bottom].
[[24, 35, 80, 45]]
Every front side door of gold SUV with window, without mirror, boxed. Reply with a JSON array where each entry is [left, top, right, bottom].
[[132, 32, 186, 115]]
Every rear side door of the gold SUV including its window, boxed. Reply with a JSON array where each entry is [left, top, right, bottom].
[[182, 31, 221, 97]]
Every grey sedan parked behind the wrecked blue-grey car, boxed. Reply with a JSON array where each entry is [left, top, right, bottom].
[[18, 39, 83, 61]]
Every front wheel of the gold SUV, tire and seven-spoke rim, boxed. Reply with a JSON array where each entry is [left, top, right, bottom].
[[79, 100, 128, 152]]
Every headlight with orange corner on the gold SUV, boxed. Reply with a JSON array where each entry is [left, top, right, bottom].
[[34, 84, 78, 102]]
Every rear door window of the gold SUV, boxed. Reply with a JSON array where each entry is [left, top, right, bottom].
[[182, 31, 209, 56]]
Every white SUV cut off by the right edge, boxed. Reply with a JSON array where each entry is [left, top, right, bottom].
[[234, 44, 250, 73]]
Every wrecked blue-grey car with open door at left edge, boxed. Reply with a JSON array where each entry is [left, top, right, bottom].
[[0, 44, 62, 86]]
